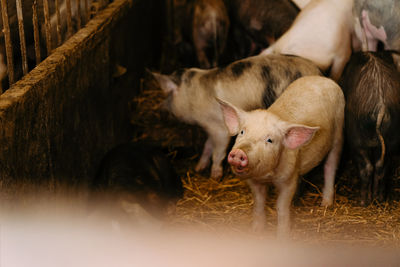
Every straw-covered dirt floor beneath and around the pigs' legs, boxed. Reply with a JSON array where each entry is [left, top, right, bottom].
[[131, 74, 400, 247]]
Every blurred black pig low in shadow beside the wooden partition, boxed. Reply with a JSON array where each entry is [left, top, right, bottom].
[[90, 142, 183, 228]]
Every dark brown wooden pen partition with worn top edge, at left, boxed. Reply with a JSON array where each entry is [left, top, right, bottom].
[[0, 0, 166, 186]]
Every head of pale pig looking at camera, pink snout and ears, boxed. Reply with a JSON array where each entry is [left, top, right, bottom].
[[218, 100, 319, 179]]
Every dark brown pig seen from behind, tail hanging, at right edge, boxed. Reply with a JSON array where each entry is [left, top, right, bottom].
[[341, 51, 400, 205]]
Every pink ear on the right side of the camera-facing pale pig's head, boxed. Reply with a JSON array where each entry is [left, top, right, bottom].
[[283, 124, 319, 149]]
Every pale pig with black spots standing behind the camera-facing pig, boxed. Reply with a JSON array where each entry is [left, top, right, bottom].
[[152, 55, 321, 178]]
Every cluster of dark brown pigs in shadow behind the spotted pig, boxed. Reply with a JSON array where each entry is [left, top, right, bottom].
[[170, 0, 299, 68]]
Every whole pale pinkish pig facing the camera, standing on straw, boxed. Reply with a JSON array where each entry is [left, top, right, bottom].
[[219, 76, 345, 237]]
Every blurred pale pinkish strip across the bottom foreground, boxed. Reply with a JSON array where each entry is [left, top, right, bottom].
[[0, 199, 400, 267]]
